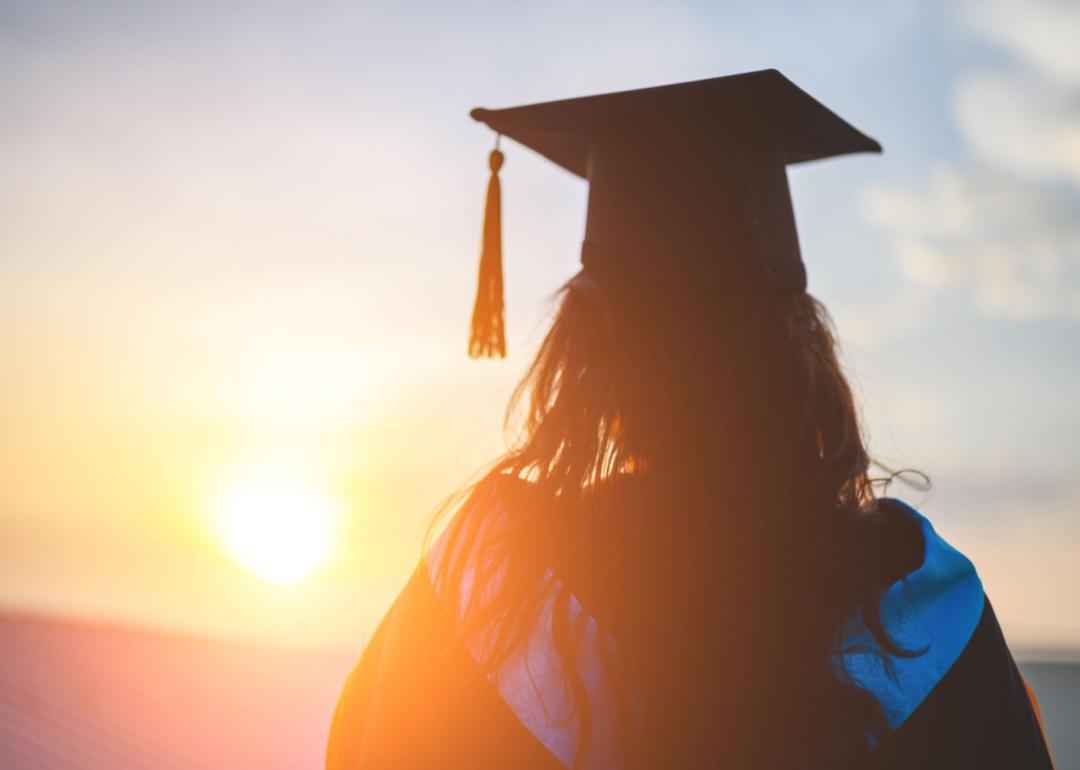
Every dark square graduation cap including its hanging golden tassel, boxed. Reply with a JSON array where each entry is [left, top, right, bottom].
[[469, 69, 881, 357]]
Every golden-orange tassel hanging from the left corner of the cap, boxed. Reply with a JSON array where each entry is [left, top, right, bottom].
[[469, 135, 507, 359]]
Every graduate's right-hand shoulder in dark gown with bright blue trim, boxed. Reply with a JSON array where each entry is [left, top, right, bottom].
[[834, 498, 1053, 770]]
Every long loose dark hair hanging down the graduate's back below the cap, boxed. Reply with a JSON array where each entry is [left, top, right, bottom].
[[425, 271, 919, 769]]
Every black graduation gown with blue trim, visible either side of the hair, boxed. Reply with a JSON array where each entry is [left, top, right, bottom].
[[326, 483, 1052, 770]]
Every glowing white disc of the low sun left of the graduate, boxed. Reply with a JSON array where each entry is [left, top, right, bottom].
[[219, 478, 336, 583]]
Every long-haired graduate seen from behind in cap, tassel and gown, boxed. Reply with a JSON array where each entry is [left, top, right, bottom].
[[326, 70, 1052, 770]]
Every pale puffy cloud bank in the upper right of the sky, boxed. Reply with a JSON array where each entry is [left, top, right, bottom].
[[863, 0, 1080, 320]]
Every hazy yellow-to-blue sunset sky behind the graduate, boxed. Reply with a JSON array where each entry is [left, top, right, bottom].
[[0, 0, 1080, 650]]
